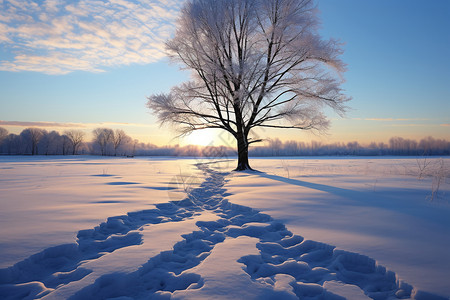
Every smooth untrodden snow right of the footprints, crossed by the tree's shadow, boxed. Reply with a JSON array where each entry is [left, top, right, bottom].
[[226, 158, 450, 295]]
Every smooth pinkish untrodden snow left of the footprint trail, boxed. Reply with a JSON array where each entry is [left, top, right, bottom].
[[0, 156, 202, 268]]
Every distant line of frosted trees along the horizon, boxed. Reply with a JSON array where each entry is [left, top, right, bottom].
[[0, 127, 450, 157]]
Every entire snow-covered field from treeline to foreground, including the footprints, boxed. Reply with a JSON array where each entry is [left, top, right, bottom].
[[0, 156, 450, 299]]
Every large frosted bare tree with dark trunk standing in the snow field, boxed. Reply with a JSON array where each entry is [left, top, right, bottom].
[[147, 0, 350, 170]]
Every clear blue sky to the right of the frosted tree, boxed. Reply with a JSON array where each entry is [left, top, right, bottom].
[[319, 0, 450, 140]]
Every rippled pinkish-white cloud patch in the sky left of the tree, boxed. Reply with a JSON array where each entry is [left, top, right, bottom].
[[0, 0, 183, 74]]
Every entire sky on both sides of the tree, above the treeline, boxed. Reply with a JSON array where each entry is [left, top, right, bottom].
[[0, 0, 450, 146]]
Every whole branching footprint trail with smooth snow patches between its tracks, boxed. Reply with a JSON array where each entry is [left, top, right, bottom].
[[0, 164, 443, 299]]
